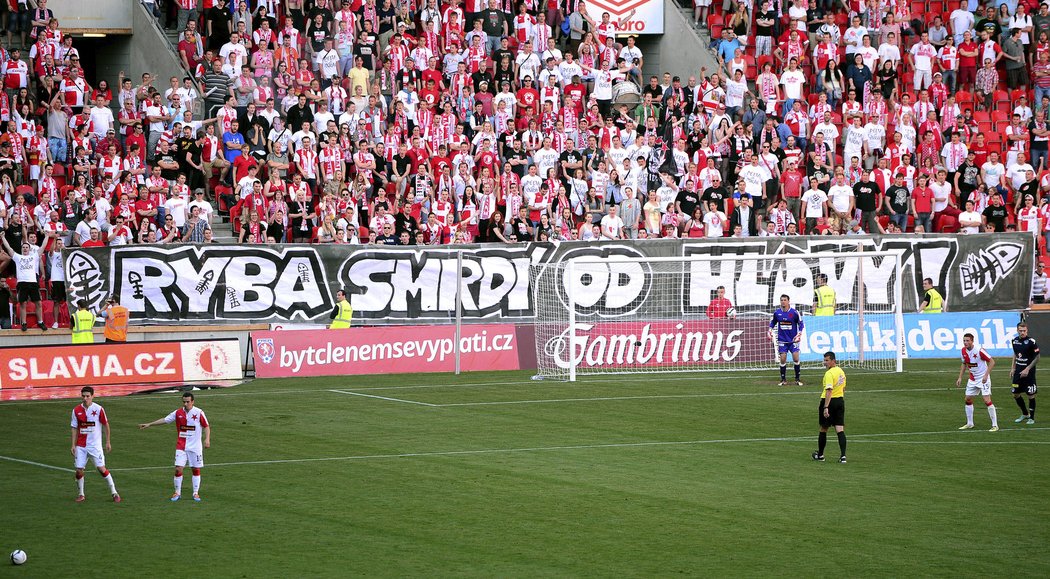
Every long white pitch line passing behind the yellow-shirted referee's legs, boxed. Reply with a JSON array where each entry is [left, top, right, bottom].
[[110, 428, 1050, 472]]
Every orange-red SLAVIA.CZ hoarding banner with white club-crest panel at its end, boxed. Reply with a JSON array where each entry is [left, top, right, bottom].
[[0, 338, 243, 390]]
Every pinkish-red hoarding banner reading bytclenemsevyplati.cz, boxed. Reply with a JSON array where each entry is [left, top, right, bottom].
[[251, 324, 521, 378]]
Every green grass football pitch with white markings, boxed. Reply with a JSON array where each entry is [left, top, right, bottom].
[[0, 360, 1050, 578]]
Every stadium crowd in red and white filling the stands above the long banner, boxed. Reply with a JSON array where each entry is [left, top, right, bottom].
[[0, 0, 1050, 251]]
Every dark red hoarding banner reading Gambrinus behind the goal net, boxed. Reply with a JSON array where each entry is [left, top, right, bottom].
[[542, 318, 775, 368]]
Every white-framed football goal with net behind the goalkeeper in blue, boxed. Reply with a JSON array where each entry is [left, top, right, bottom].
[[532, 251, 904, 380]]
